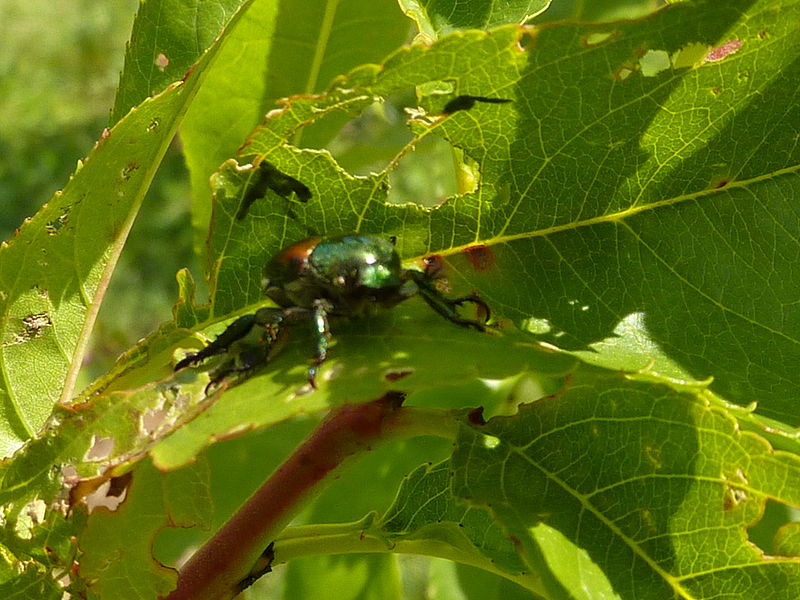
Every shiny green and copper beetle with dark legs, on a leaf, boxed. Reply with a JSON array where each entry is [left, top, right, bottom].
[[175, 234, 490, 388]]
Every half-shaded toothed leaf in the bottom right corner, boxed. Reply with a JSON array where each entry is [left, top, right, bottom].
[[452, 370, 800, 600]]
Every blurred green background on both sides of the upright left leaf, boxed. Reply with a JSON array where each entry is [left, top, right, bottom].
[[0, 0, 198, 383]]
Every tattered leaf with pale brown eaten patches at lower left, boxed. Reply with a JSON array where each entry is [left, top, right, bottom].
[[0, 370, 216, 578]]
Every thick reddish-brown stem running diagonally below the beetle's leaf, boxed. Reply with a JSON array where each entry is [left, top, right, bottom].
[[167, 392, 404, 600]]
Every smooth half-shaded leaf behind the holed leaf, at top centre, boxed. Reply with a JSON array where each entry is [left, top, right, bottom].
[[182, 0, 409, 254]]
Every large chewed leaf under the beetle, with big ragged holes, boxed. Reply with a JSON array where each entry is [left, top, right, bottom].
[[126, 3, 800, 466]]
